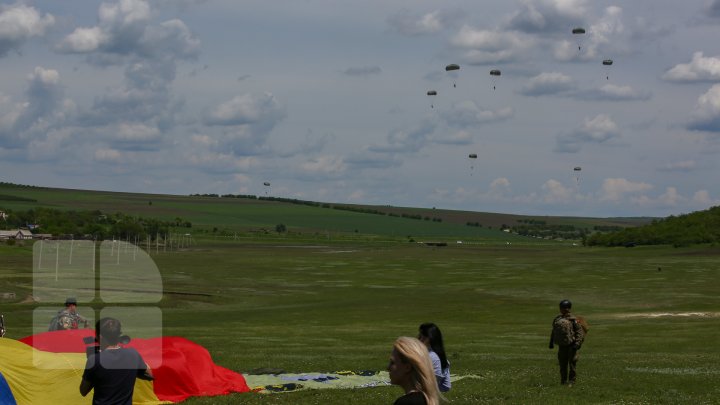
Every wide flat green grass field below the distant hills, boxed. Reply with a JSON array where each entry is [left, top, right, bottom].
[[0, 238, 720, 404]]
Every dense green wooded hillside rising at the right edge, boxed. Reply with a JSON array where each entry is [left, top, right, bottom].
[[585, 206, 720, 247]]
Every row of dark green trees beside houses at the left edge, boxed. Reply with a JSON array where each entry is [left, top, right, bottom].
[[0, 207, 192, 240]]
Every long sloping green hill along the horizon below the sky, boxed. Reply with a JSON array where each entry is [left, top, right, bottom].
[[0, 183, 651, 240]]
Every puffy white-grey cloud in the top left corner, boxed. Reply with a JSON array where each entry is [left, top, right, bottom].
[[0, 4, 55, 57]]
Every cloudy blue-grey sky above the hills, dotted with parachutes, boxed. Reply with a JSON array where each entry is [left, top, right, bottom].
[[0, 0, 720, 217]]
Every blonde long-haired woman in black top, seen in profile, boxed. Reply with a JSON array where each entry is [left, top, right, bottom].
[[388, 336, 440, 405]]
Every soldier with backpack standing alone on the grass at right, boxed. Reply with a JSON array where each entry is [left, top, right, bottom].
[[549, 300, 585, 386]]
